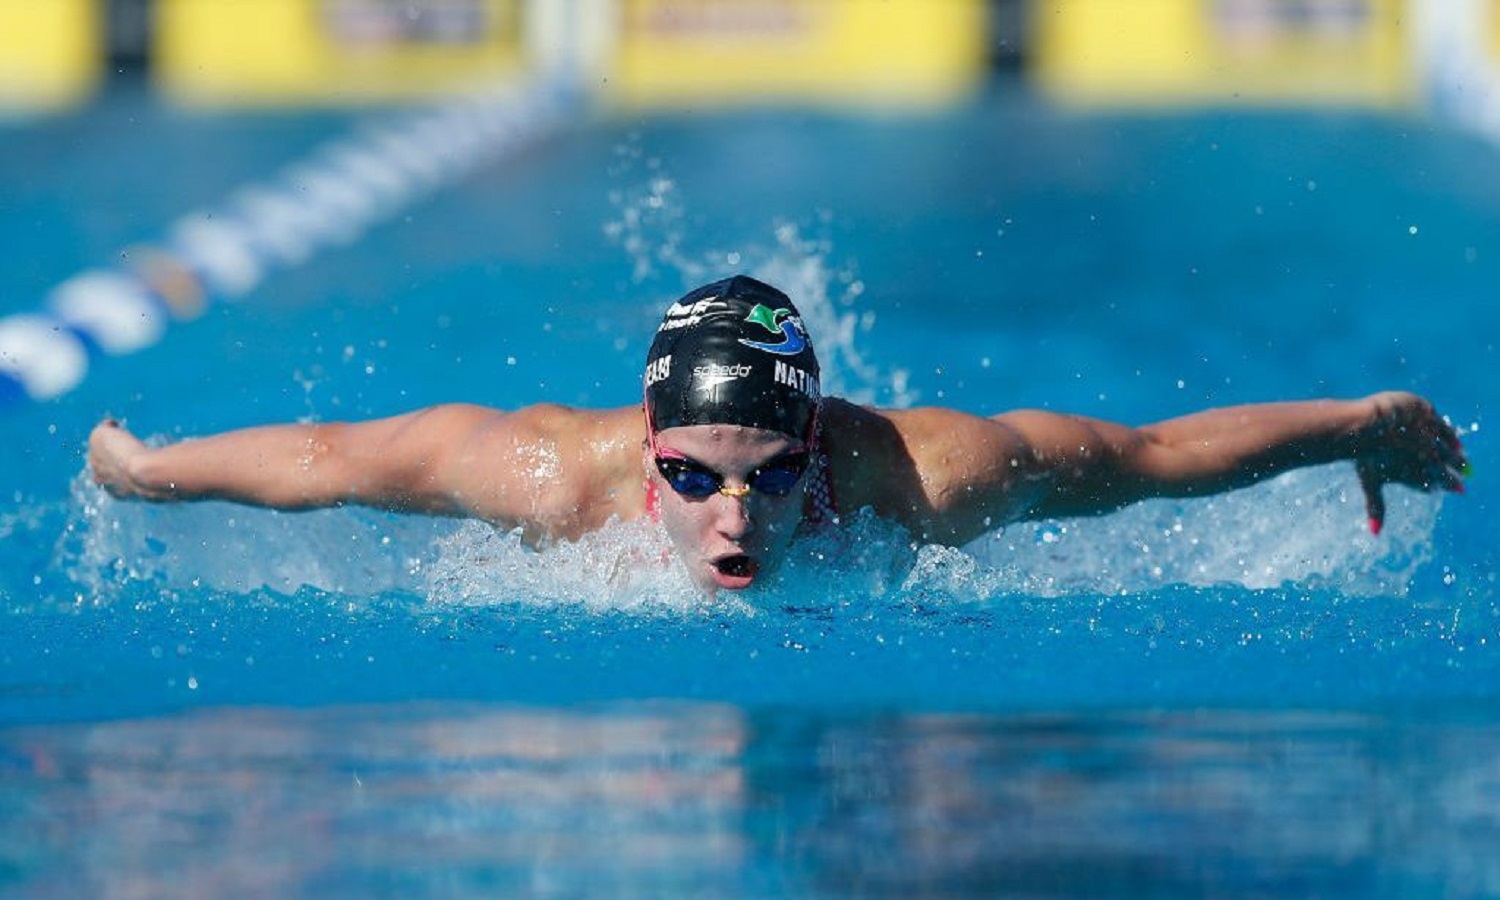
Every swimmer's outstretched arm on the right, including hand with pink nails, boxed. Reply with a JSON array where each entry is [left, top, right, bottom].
[[888, 392, 1467, 542]]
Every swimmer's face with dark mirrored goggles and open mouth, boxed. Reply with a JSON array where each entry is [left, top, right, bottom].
[[645, 425, 807, 594]]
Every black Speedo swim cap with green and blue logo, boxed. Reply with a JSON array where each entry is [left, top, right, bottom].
[[645, 275, 822, 441]]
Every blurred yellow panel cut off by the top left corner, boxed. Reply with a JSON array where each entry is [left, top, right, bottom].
[[0, 0, 104, 111]]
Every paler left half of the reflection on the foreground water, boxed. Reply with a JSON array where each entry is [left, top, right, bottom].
[[0, 707, 746, 897]]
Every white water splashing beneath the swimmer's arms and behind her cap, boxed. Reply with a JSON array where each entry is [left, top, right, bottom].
[[56, 154, 1440, 614]]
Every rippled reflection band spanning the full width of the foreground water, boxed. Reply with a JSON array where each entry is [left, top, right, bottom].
[[0, 704, 1500, 897]]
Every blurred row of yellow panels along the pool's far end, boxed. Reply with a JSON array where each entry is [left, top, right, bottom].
[[0, 0, 1500, 113]]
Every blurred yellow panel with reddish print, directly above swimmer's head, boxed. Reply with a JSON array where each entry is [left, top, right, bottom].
[[608, 0, 986, 105]]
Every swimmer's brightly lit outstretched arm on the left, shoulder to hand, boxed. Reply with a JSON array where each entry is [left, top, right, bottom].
[[89, 404, 639, 539]]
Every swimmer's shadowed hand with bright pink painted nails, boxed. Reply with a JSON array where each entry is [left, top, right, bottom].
[[1355, 392, 1469, 534]]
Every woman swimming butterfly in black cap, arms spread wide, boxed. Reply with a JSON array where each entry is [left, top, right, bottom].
[[89, 276, 1467, 594]]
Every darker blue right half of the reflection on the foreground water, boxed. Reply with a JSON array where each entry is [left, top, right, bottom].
[[803, 713, 1500, 897]]
